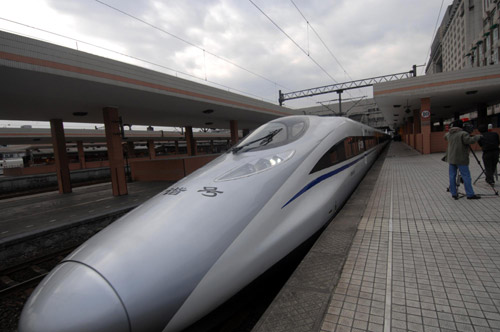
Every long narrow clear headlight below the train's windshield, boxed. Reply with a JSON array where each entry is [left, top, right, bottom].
[[215, 150, 295, 181]]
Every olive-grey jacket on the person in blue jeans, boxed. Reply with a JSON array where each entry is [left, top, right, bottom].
[[444, 127, 481, 165]]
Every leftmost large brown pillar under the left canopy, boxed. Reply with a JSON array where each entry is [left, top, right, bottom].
[[50, 119, 71, 194]]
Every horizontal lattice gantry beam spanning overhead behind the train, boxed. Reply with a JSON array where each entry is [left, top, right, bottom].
[[278, 65, 417, 106]]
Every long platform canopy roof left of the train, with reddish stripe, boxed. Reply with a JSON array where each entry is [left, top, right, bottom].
[[0, 31, 299, 129]]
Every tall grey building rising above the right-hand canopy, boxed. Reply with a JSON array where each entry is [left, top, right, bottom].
[[426, 0, 500, 74]]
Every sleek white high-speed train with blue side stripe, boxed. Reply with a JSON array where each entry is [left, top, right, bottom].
[[19, 116, 387, 332]]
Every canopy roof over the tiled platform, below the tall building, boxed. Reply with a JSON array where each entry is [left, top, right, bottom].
[[373, 65, 500, 126]]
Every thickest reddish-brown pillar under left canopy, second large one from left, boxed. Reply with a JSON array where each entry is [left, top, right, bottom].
[[102, 107, 128, 196]]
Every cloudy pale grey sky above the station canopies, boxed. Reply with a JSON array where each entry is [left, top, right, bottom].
[[0, 0, 446, 128]]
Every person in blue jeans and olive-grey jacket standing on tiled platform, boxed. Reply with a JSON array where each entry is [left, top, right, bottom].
[[444, 120, 481, 199]]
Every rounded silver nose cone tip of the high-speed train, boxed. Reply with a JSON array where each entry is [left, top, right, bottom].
[[19, 262, 130, 332]]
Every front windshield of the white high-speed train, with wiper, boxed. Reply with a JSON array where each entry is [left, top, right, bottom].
[[229, 117, 309, 153]]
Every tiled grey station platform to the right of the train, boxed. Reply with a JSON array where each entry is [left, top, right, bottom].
[[252, 142, 500, 332]]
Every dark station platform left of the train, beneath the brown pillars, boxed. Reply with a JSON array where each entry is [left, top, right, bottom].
[[0, 181, 172, 248]]
